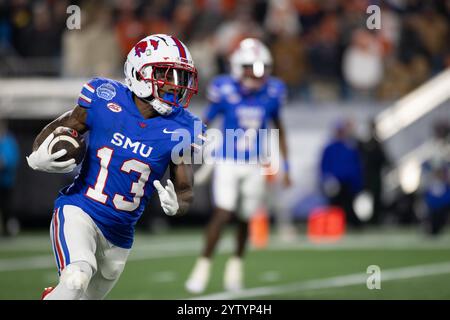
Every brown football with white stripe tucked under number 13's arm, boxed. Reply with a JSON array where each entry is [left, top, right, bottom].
[[48, 127, 86, 165]]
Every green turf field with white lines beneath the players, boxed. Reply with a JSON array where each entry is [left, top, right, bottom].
[[0, 229, 450, 299]]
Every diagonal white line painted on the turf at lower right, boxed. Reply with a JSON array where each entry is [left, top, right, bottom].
[[189, 261, 450, 300]]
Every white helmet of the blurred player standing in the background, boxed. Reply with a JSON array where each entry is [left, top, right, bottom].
[[230, 38, 272, 89]]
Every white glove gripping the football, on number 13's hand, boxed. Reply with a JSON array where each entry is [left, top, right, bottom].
[[26, 133, 77, 173]]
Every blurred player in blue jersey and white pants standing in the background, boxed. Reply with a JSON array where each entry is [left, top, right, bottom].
[[186, 38, 291, 293]]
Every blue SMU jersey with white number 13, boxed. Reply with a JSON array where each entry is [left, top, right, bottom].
[[55, 78, 204, 248]]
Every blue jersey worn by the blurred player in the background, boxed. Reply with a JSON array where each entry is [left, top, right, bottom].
[[205, 75, 286, 160]]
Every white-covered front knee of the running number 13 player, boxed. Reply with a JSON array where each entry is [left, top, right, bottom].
[[59, 262, 92, 293]]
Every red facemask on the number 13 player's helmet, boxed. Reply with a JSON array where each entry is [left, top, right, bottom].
[[138, 63, 198, 108]]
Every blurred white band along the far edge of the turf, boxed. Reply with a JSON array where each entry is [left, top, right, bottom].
[[0, 235, 450, 272]]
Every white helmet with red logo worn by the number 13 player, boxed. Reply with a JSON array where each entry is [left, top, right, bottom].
[[124, 34, 198, 115]]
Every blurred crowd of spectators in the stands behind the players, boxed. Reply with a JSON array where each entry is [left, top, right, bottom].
[[0, 0, 450, 102]]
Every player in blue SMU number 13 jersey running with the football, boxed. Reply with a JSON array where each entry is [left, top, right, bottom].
[[27, 34, 204, 299]]
